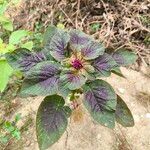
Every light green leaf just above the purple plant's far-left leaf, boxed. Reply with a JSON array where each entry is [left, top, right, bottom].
[[9, 30, 29, 44]]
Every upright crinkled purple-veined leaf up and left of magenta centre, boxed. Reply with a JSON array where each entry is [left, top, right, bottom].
[[46, 30, 70, 61]]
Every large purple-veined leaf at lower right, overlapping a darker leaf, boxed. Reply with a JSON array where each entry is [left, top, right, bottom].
[[83, 80, 117, 128]]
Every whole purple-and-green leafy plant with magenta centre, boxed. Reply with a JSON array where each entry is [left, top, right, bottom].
[[6, 26, 137, 149]]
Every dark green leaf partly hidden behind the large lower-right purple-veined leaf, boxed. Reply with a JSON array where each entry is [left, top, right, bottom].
[[115, 95, 134, 127]]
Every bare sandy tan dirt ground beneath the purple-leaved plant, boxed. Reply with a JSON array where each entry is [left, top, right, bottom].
[[3, 65, 150, 150]]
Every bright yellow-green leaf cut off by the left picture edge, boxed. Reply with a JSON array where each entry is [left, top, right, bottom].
[[0, 60, 13, 92]]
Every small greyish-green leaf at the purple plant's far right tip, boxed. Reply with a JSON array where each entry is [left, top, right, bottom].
[[113, 49, 137, 66]]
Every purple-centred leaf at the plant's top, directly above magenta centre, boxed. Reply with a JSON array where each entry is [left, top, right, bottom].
[[70, 30, 91, 51]]
